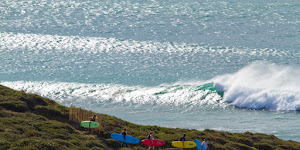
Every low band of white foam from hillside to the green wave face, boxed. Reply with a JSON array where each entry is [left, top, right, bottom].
[[0, 81, 221, 107]]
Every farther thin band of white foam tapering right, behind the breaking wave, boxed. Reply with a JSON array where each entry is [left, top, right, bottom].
[[0, 32, 285, 55]]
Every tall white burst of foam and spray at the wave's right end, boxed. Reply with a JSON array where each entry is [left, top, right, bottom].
[[213, 62, 300, 111]]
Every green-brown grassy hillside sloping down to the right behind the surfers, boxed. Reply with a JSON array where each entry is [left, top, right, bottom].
[[0, 85, 300, 150]]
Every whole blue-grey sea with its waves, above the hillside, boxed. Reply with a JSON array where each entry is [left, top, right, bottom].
[[0, 0, 300, 142]]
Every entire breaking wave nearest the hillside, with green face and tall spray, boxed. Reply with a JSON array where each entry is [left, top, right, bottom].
[[1, 62, 300, 111]]
